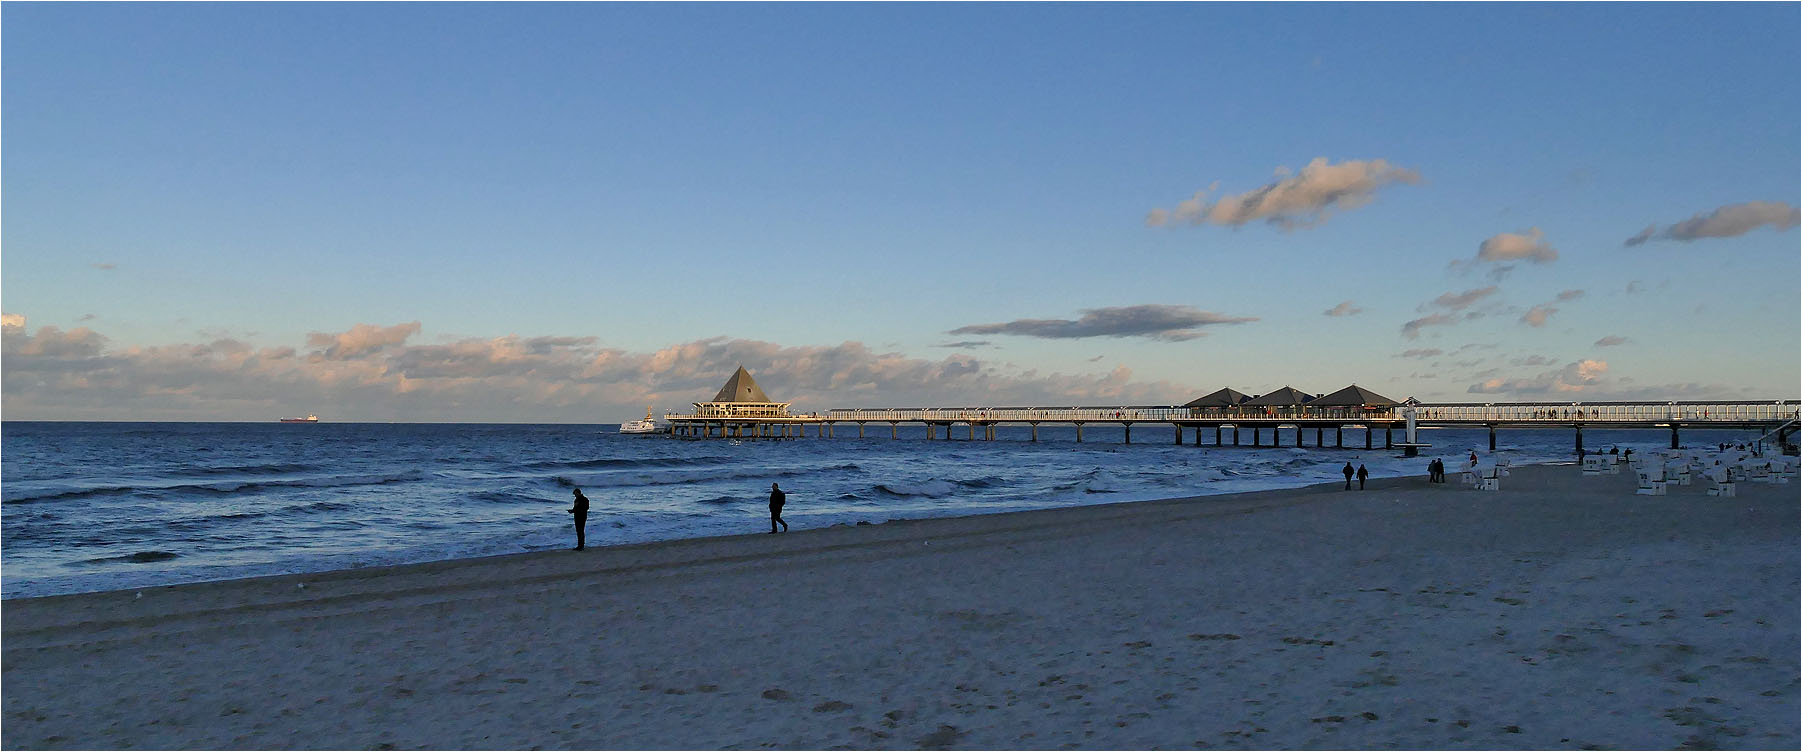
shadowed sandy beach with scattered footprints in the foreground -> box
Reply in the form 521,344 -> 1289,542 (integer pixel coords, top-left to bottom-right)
0,465 -> 1803,749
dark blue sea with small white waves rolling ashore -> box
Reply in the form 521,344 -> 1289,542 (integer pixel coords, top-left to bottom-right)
0,422 -> 1758,598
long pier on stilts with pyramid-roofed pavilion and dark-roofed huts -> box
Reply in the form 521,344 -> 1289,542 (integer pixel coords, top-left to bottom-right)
664,366 -> 1799,456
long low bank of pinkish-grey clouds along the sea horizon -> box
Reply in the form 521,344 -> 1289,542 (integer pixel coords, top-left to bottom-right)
0,315 -> 1194,423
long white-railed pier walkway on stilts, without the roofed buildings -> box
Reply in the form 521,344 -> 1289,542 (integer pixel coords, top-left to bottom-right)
664,400 -> 1798,454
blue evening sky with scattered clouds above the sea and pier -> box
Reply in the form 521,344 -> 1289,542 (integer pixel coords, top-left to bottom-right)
0,4 -> 1799,422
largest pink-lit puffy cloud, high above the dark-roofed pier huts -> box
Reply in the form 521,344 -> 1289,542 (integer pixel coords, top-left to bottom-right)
1145,157 -> 1421,231
